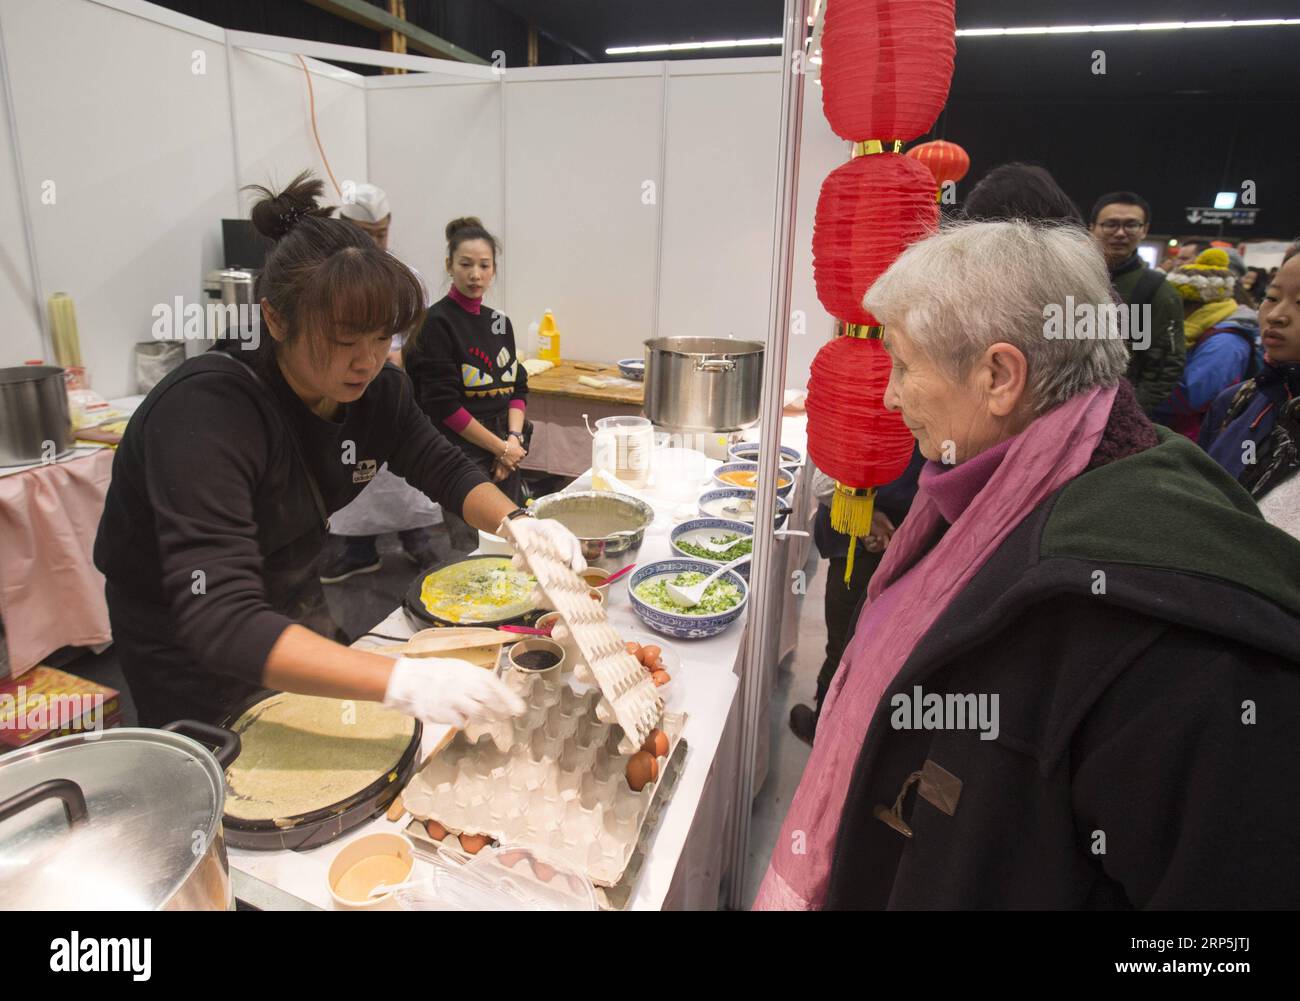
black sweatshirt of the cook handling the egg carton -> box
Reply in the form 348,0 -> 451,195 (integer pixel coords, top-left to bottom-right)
95,341 -> 486,684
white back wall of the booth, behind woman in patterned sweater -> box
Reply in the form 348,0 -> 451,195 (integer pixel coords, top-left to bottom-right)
367,57 -> 848,386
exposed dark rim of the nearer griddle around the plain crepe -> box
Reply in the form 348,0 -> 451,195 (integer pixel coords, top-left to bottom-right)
221,692 -> 424,852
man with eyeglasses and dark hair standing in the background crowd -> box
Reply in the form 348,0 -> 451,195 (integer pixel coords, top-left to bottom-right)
1089,191 -> 1187,416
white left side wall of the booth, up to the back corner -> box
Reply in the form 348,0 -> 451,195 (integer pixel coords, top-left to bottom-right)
0,0 -> 367,398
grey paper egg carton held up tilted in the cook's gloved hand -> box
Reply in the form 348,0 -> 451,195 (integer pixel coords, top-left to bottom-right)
504,523 -> 663,754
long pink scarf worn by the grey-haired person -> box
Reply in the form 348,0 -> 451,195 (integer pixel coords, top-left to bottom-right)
754,386 -> 1117,910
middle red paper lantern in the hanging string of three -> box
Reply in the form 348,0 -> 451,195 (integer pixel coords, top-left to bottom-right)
813,153 -> 939,325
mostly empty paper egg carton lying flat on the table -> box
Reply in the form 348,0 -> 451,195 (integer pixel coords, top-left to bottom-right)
402,672 -> 686,883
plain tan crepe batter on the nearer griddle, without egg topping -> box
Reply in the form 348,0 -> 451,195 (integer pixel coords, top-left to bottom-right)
226,693 -> 415,820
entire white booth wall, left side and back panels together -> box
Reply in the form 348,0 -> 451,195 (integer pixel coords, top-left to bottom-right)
0,0 -> 848,397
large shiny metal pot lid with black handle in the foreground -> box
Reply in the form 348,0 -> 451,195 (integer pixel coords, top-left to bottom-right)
0,728 -> 225,910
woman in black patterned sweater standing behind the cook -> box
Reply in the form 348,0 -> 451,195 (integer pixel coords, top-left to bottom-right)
403,217 -> 530,549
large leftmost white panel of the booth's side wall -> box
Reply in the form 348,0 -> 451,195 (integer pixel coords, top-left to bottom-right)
0,0 -> 234,395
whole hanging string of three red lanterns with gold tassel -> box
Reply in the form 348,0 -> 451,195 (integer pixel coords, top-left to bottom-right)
807,0 -> 956,582
